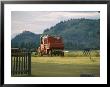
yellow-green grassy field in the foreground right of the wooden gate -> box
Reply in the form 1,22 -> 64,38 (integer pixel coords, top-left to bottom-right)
31,56 -> 100,77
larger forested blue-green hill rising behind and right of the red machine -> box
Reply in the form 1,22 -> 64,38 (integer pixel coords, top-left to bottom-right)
43,19 -> 100,50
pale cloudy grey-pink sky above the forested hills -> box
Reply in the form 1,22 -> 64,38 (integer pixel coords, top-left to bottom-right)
11,11 -> 100,38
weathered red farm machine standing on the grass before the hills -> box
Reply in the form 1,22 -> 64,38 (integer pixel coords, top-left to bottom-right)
38,35 -> 64,56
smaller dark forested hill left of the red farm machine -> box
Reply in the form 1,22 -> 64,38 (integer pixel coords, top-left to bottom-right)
11,31 -> 40,49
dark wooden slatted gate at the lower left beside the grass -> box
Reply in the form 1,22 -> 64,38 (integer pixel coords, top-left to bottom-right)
11,49 -> 31,76
